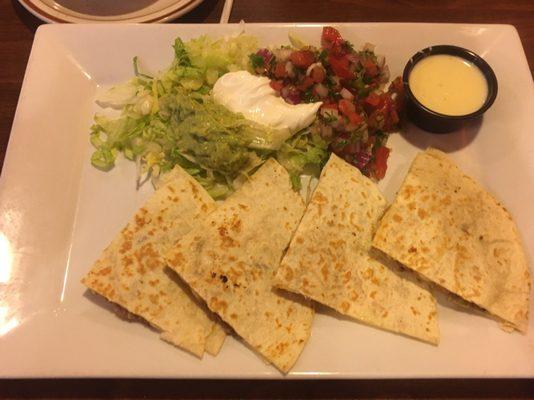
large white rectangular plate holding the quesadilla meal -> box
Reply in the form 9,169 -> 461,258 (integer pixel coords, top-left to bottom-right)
0,23 -> 534,378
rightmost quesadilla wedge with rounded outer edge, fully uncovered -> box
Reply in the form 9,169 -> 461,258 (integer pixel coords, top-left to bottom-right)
373,149 -> 530,332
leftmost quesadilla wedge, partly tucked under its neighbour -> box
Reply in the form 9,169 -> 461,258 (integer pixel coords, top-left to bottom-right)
82,167 -> 225,357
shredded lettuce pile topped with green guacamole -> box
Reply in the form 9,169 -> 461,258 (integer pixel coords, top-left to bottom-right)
91,35 -> 327,199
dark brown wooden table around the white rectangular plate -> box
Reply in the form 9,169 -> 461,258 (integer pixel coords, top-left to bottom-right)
0,0 -> 534,399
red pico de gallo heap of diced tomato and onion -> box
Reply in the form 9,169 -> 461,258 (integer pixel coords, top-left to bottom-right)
250,26 -> 404,180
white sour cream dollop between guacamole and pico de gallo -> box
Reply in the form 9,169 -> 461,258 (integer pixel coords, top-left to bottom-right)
213,71 -> 322,133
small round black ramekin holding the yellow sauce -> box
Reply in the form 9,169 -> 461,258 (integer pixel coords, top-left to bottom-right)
402,45 -> 498,133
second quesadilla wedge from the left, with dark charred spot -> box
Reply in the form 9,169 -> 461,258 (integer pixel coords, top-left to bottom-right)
167,159 -> 313,372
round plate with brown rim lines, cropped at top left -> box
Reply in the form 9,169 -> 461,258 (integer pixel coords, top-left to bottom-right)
19,0 -> 203,23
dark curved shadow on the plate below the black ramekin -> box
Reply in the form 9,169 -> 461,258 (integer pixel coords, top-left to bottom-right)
401,117 -> 483,153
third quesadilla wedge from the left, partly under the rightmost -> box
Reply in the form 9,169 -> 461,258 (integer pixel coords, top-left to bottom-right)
275,154 -> 439,344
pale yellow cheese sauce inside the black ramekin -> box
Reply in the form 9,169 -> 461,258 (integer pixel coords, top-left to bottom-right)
408,54 -> 488,115
